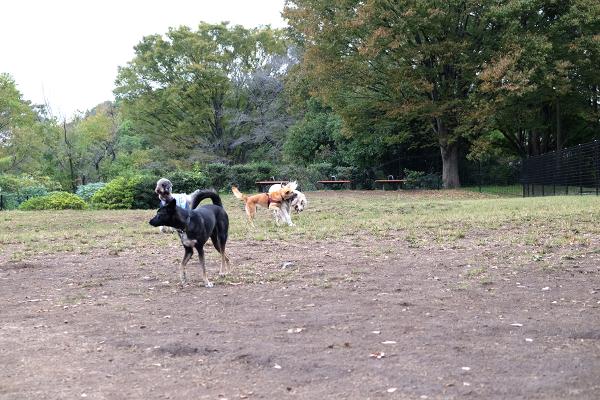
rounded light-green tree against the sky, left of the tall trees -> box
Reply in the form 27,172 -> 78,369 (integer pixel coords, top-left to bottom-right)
115,23 -> 285,166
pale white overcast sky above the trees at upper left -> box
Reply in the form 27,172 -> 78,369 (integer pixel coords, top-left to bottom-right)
0,0 -> 285,119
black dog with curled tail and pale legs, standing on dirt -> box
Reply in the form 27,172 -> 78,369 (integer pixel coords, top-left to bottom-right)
149,190 -> 229,287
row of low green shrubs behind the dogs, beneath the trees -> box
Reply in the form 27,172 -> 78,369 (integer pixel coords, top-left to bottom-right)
21,162 -> 439,209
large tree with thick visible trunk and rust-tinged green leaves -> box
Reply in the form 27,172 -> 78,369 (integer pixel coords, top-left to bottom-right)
284,0 -> 496,187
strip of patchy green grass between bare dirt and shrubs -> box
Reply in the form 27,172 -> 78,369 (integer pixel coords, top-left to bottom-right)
0,190 -> 600,261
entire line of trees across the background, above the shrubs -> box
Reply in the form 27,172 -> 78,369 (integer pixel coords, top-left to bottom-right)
0,0 -> 600,192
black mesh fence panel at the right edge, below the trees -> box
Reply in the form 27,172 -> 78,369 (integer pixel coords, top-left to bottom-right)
521,141 -> 600,196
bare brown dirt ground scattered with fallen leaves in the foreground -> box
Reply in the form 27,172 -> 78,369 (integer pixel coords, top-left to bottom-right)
0,196 -> 600,399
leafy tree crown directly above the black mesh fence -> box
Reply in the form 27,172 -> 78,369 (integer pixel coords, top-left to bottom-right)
477,0 -> 600,157
